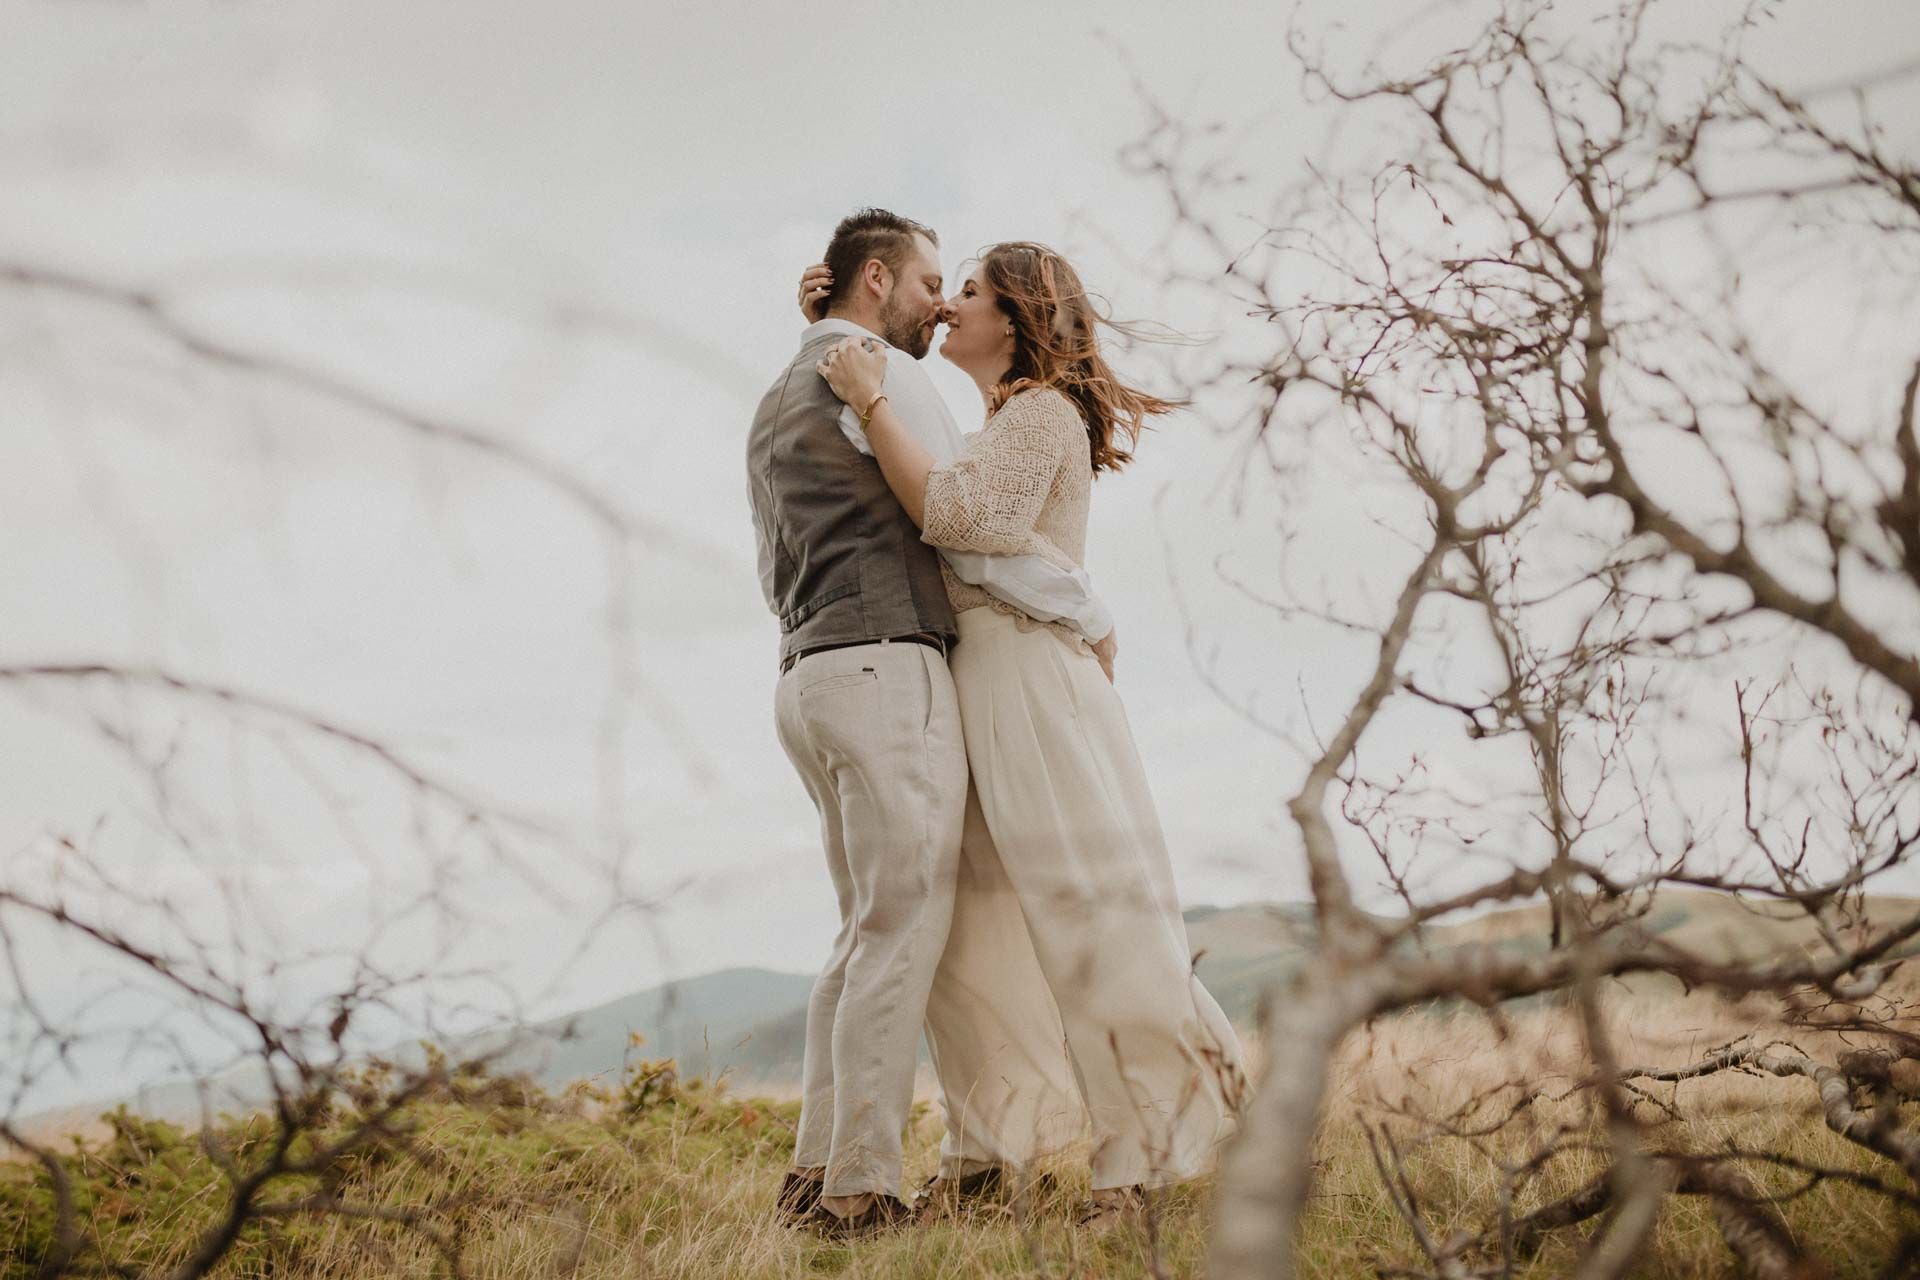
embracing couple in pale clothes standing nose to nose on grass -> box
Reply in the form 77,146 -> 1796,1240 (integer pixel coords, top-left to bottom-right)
747,209 -> 1244,1236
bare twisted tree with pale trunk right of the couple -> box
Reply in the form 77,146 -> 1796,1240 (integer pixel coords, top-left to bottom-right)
1129,2 -> 1920,1278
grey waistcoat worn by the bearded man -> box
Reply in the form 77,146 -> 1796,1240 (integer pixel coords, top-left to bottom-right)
747,332 -> 956,660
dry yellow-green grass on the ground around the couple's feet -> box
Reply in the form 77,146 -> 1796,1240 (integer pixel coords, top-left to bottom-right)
0,974 -> 1916,1280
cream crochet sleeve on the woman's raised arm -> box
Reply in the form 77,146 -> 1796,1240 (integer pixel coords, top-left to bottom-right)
920,388 -> 1087,555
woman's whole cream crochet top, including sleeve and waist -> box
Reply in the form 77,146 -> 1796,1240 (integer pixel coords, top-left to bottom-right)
920,388 -> 1092,647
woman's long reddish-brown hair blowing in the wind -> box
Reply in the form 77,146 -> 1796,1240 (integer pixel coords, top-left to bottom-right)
979,240 -> 1185,472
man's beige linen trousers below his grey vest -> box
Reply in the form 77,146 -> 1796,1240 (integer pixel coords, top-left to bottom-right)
774,641 -> 968,1196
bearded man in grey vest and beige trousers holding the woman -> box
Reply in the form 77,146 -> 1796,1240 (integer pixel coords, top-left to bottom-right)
747,209 -> 1112,1234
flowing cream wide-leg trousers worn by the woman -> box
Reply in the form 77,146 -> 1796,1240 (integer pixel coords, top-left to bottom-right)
927,608 -> 1244,1190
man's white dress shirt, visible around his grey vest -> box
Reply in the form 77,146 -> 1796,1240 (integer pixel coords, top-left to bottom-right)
801,317 -> 1114,643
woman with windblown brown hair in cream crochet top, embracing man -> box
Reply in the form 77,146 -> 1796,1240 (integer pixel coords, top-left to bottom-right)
801,242 -> 1244,1224
